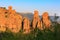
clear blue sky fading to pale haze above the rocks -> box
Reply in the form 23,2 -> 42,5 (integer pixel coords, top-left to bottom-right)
0,0 -> 60,16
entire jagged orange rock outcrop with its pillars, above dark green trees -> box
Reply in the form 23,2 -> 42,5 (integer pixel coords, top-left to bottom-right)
0,6 -> 51,34
